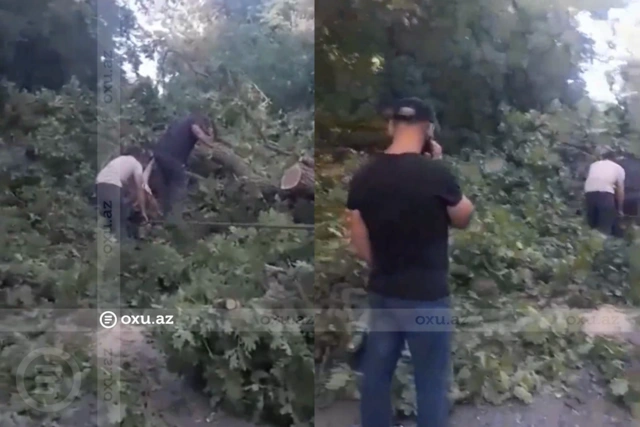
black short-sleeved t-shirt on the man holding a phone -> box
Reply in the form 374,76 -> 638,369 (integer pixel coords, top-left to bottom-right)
347,153 -> 462,301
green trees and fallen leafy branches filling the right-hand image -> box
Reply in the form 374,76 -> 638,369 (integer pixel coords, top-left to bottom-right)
314,1 -> 638,415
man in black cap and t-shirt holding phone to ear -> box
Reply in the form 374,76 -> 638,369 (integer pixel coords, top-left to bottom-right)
347,98 -> 474,427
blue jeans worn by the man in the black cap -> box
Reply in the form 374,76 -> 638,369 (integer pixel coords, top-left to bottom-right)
360,294 -> 453,427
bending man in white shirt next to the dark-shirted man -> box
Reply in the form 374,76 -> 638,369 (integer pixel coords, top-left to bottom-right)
96,147 -> 151,241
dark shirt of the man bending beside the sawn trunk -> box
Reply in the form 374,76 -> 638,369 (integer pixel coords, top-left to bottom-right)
155,114 -> 207,164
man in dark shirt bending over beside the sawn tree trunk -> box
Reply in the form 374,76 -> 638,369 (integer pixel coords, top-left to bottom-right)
145,113 -> 216,222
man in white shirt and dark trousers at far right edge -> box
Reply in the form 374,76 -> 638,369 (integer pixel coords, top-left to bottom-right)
584,152 -> 625,235
